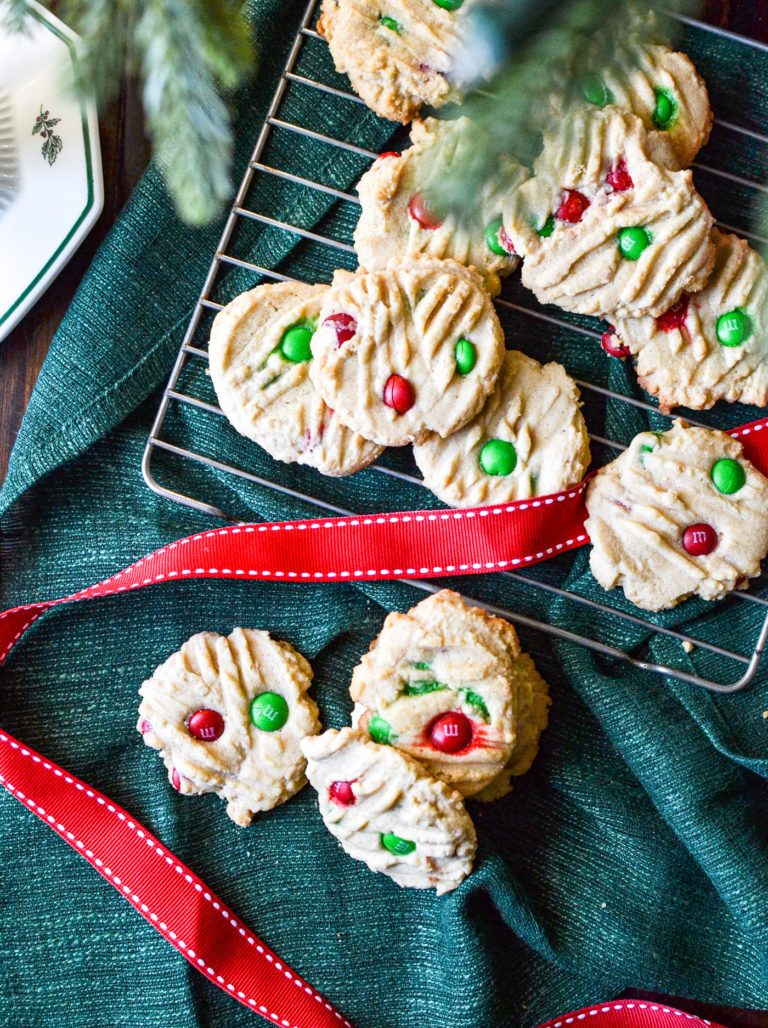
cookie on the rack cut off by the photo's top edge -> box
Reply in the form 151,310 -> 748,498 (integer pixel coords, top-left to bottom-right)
318,0 -> 473,124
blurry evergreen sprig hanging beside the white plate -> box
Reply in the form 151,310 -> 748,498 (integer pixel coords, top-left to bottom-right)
5,0 -> 254,225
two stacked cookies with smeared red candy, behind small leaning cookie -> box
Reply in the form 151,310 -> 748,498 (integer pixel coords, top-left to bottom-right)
350,589 -> 549,800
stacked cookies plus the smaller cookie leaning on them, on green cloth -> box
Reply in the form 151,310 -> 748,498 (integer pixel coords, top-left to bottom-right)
302,589 -> 549,895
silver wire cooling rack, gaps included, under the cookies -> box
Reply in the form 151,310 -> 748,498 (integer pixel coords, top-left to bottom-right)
142,0 -> 768,693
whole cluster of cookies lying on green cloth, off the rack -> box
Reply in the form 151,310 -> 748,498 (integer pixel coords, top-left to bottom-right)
137,590 -> 549,894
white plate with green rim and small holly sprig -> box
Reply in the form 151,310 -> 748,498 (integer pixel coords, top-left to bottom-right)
0,0 -> 104,340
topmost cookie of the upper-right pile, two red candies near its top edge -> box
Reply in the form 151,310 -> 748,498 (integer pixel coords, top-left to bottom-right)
504,111 -> 715,317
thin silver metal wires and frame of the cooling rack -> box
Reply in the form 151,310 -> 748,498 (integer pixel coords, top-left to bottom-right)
142,0 -> 768,693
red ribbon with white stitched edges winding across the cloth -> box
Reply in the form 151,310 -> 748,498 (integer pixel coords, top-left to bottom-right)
0,418 -> 768,1028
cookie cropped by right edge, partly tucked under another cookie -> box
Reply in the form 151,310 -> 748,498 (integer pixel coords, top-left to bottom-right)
612,229 -> 768,412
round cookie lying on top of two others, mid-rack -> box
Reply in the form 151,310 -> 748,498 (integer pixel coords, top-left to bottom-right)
309,257 -> 504,446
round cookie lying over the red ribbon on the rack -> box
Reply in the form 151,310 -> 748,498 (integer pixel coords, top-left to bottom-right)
585,421 -> 768,611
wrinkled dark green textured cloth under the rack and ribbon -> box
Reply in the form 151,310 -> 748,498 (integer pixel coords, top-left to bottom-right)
0,0 -> 768,1028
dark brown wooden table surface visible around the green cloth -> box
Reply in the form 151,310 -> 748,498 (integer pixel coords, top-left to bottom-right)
0,0 -> 768,1028
